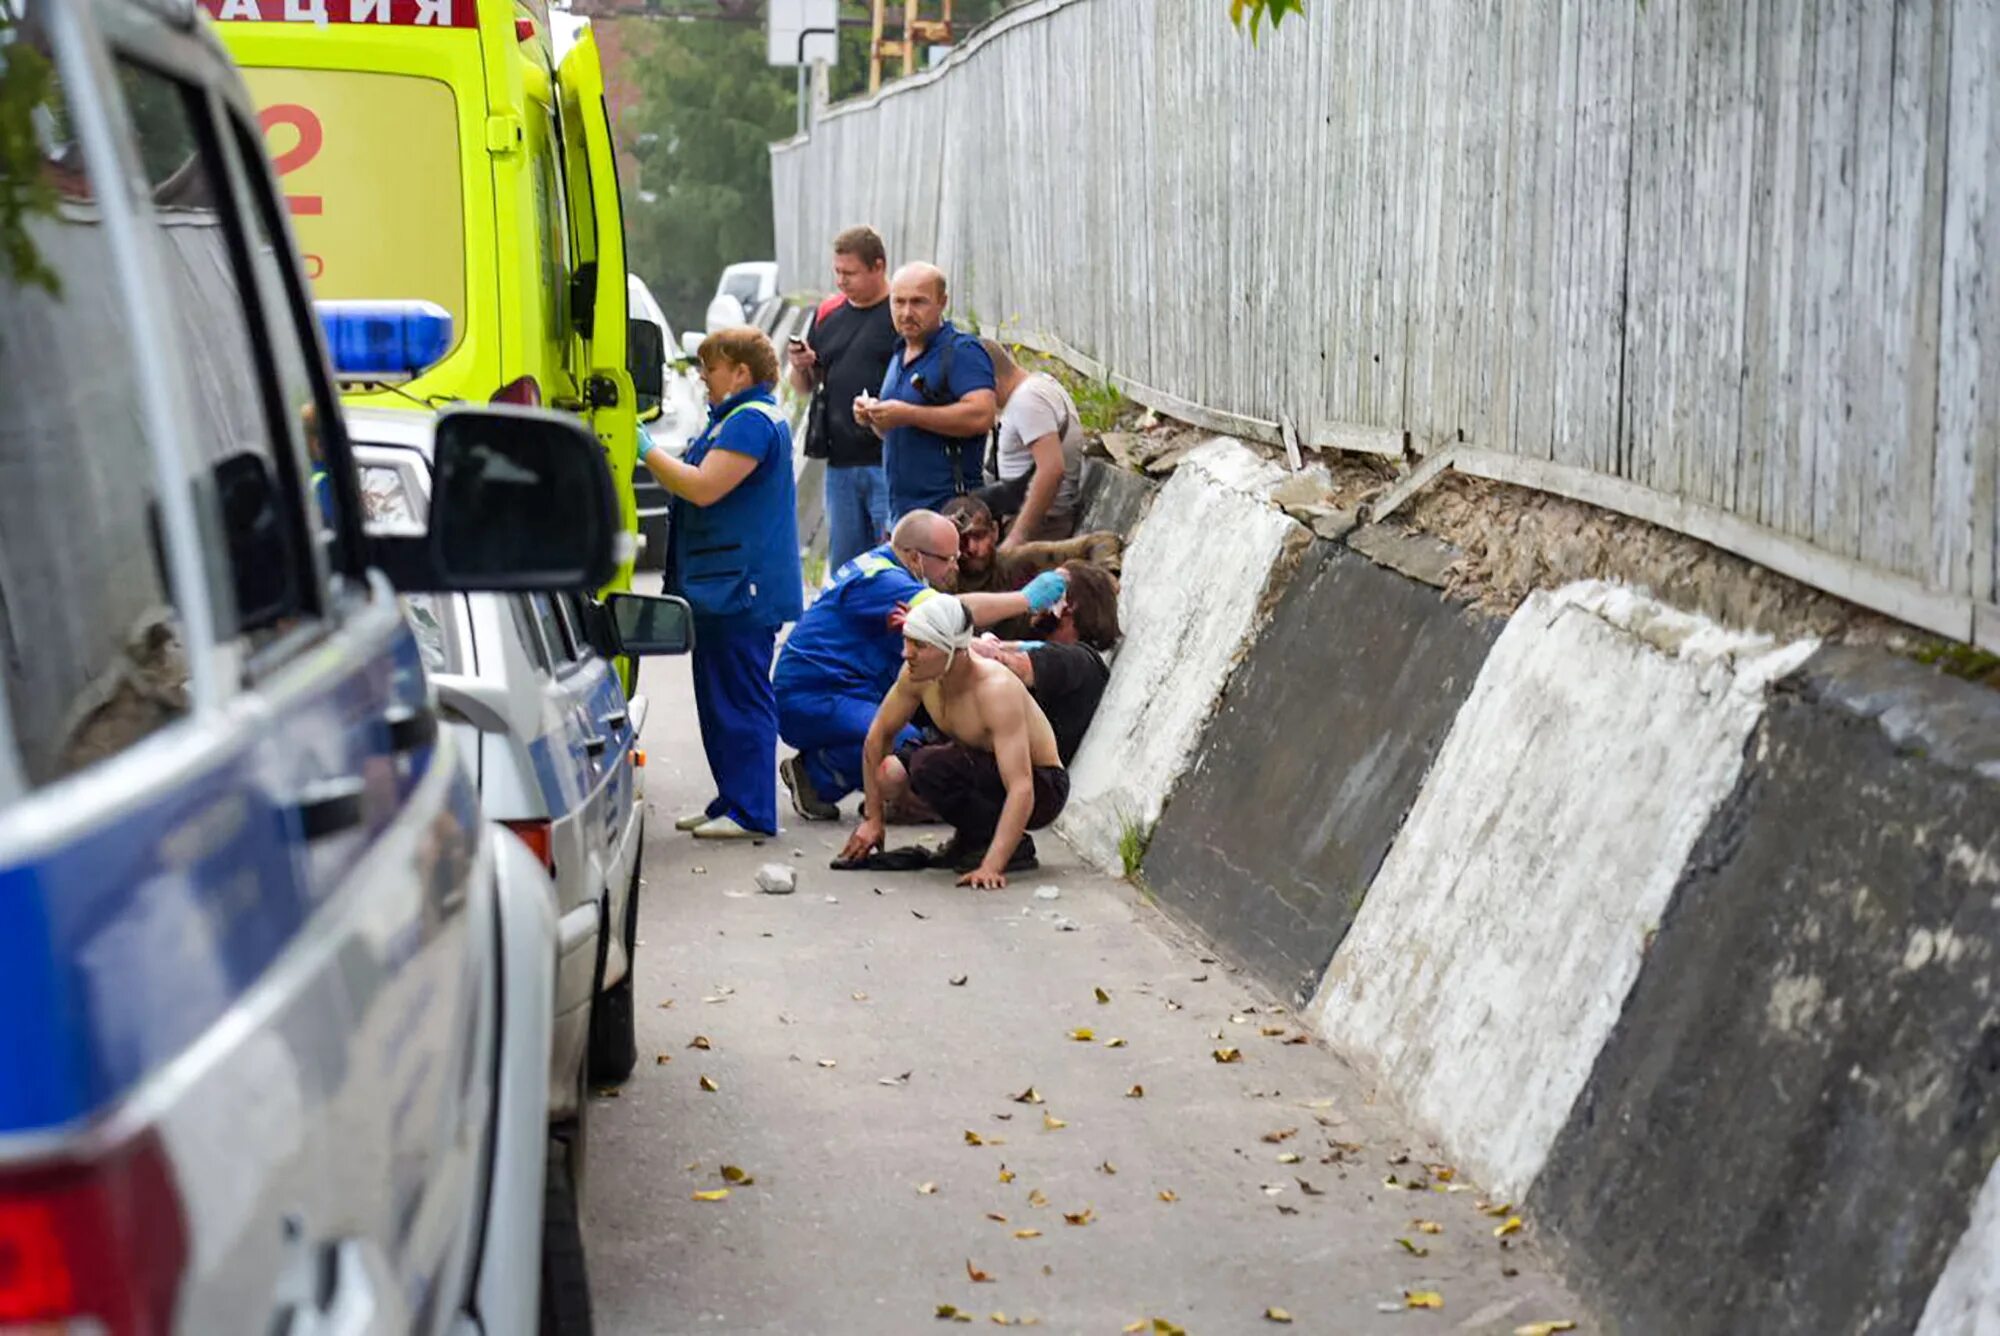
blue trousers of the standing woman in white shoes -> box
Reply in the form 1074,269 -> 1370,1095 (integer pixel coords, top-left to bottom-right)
694,618 -> 778,834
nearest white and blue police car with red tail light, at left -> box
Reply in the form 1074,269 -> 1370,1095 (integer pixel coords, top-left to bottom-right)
0,0 -> 618,1336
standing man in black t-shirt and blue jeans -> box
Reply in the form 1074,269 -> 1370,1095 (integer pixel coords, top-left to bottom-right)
790,228 -> 898,570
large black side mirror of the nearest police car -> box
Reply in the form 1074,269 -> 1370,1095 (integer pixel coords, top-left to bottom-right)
368,404 -> 620,592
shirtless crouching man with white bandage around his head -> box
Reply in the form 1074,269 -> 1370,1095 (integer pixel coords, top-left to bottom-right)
840,594 -> 1070,890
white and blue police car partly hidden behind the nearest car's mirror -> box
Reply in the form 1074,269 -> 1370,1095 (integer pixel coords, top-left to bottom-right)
348,408 -> 692,1118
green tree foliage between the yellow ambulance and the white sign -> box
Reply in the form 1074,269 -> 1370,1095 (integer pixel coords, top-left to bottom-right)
618,22 -> 798,330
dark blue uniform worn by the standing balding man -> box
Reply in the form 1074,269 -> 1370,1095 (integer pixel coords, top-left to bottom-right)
880,320 -> 994,524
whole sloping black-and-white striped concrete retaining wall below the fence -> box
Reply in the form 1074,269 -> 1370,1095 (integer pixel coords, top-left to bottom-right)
1066,446 -> 2000,1336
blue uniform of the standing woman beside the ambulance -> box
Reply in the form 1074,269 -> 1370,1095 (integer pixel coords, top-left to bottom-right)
666,384 -> 804,834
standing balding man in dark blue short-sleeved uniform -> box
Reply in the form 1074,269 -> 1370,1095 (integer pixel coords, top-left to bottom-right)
854,264 -> 1000,522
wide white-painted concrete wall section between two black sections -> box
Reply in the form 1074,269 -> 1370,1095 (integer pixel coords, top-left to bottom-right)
1314,584 -> 1810,1194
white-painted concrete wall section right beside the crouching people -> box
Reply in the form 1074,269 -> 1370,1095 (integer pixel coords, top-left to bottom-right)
1058,438 -> 1306,870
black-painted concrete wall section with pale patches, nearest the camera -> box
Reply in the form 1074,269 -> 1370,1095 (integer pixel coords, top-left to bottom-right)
1530,650 -> 2000,1334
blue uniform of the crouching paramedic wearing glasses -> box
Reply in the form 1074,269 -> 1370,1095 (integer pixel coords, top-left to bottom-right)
776,544 -> 930,802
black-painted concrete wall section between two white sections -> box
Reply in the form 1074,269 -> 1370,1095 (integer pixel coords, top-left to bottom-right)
1146,544 -> 1506,1004
